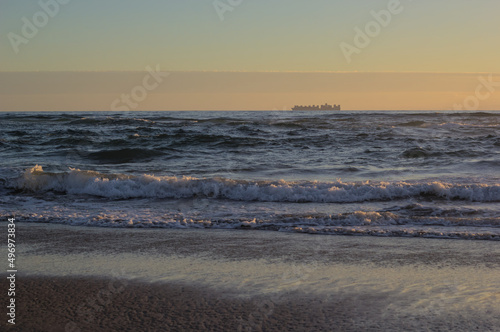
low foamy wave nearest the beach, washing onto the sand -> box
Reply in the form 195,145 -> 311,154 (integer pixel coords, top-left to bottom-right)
0,207 -> 500,241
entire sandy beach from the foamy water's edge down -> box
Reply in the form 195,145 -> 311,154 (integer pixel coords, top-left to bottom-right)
2,223 -> 500,331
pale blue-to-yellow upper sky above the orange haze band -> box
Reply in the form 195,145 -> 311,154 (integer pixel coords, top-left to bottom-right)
0,0 -> 500,72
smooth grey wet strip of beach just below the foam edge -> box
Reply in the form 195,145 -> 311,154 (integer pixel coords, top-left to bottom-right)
11,221 -> 500,269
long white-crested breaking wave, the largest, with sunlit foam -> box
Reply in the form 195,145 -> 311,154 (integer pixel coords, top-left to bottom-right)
8,165 -> 500,203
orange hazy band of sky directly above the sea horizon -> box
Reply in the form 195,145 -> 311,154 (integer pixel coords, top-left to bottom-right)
0,72 -> 500,111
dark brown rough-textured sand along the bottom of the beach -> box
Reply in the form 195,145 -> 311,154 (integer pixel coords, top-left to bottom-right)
7,277 -> 498,331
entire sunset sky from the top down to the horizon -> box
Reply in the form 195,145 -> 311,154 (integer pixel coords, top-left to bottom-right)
0,0 -> 500,111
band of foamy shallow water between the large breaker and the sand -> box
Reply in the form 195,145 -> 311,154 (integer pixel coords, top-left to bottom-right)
0,180 -> 500,241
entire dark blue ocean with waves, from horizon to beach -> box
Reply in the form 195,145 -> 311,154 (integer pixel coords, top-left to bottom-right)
0,111 -> 500,241
